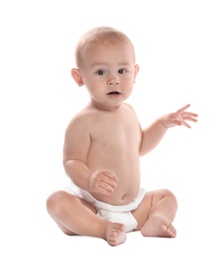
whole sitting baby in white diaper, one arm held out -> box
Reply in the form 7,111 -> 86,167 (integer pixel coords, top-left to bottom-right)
47,27 -> 197,246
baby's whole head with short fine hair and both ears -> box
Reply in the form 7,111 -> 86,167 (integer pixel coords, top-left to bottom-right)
71,27 -> 139,109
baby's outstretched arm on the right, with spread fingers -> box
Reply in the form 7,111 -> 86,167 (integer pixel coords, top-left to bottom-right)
140,104 -> 198,156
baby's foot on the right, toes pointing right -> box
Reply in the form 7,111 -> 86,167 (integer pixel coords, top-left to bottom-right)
141,216 -> 176,238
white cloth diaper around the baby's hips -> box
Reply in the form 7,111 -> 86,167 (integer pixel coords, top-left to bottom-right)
64,182 -> 146,232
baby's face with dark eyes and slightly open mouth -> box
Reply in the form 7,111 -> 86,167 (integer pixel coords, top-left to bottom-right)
80,42 -> 138,109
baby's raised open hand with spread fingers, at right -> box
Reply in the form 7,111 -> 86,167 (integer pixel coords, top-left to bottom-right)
161,104 -> 198,128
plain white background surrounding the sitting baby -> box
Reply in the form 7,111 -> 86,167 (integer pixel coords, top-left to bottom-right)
0,0 -> 221,259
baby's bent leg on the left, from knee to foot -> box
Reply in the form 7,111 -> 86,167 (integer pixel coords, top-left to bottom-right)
47,191 -> 126,245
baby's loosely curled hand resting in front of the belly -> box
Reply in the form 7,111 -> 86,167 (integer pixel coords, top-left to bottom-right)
90,170 -> 118,195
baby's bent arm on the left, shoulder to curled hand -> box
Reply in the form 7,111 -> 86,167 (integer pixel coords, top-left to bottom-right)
63,118 -> 117,195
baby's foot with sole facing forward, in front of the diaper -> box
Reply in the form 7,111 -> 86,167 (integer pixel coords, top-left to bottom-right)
106,222 -> 127,246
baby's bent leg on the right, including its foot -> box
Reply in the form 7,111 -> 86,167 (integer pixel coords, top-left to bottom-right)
133,190 -> 177,237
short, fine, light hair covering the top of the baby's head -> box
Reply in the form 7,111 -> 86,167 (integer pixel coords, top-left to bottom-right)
75,26 -> 135,69
